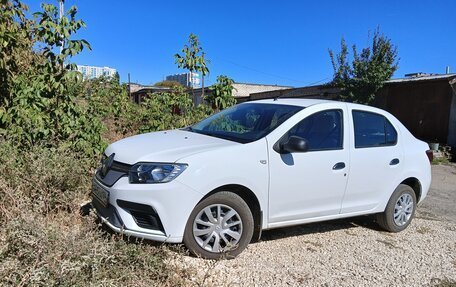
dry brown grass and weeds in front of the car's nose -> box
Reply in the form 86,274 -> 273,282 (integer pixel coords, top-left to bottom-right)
0,142 -> 200,286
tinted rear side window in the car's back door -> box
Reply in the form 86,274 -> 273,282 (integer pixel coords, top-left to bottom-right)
353,111 -> 397,148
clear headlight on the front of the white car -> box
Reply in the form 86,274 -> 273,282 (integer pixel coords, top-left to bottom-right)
130,163 -> 187,183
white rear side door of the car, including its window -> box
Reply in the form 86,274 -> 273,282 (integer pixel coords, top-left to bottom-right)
341,109 -> 403,213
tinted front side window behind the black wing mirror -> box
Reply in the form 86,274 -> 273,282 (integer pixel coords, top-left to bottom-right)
286,110 -> 343,151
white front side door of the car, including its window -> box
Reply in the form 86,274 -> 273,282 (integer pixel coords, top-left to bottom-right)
268,109 -> 349,225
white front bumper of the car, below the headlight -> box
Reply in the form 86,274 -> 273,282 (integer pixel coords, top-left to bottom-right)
92,177 -> 203,243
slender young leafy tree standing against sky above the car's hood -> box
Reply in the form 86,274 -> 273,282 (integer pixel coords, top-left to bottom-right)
174,34 -> 209,97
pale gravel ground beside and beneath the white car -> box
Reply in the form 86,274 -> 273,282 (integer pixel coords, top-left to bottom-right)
170,166 -> 456,286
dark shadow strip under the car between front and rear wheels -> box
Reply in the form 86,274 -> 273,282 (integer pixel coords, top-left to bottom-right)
258,215 -> 382,242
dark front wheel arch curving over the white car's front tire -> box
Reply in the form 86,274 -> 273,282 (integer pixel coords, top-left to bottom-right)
199,184 -> 263,242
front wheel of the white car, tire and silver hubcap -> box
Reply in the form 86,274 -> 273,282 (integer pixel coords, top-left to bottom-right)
184,191 -> 254,259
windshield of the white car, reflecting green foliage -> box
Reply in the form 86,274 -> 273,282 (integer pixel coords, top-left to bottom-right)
188,103 -> 303,143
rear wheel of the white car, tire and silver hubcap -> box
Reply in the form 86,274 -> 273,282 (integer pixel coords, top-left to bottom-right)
377,184 -> 416,232
